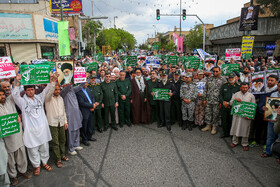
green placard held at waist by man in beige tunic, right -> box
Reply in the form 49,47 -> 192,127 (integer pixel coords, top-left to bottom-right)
231,100 -> 257,119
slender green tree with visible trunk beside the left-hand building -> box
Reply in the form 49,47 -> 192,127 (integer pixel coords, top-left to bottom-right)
83,20 -> 103,53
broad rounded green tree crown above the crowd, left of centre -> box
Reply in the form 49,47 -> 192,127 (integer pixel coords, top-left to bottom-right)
96,28 -> 136,50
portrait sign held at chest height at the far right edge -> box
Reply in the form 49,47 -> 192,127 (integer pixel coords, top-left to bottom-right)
264,97 -> 280,121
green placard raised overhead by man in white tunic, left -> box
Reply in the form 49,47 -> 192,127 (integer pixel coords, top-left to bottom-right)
19,64 -> 50,85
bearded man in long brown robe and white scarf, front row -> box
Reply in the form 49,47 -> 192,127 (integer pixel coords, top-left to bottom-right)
130,68 -> 150,125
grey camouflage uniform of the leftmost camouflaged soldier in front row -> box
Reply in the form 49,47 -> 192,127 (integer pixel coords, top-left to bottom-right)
180,82 -> 198,122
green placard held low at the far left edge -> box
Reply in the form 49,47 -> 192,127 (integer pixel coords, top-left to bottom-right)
0,113 -> 20,138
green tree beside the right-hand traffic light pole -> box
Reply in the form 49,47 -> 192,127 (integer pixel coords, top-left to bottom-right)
184,25 -> 203,50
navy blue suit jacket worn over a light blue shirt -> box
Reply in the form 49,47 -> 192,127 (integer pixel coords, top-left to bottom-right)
76,88 -> 95,120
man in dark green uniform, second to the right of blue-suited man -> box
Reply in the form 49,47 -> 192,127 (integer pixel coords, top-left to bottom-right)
101,73 -> 119,131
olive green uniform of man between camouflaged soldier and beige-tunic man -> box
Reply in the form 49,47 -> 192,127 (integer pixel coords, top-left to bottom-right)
219,83 -> 240,136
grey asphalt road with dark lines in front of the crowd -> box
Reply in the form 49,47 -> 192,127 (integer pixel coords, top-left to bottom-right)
17,124 -> 280,187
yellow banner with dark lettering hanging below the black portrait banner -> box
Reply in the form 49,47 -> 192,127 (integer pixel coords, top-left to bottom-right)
241,36 -> 255,60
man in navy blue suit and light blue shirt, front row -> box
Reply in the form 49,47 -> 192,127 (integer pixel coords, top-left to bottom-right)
76,84 -> 96,146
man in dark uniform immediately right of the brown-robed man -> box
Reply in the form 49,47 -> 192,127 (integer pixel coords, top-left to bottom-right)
147,70 -> 159,124
